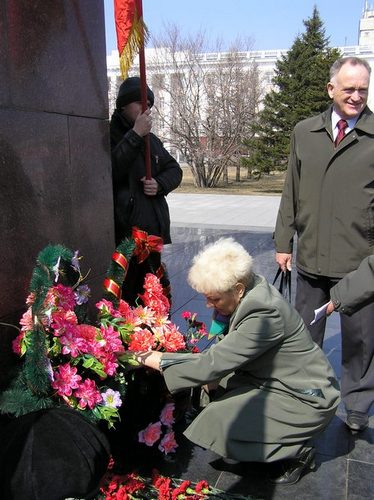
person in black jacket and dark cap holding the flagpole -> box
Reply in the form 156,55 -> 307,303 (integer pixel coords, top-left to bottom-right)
110,77 -> 182,305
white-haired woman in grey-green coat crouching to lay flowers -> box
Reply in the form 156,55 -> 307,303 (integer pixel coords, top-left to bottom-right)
137,238 -> 340,484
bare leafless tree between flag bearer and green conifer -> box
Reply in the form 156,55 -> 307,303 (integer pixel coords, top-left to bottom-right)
147,26 -> 260,187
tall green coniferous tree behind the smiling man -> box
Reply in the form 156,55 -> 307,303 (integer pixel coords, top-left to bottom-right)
244,7 -> 340,173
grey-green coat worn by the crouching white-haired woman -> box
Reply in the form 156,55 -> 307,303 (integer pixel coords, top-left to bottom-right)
161,275 -> 340,462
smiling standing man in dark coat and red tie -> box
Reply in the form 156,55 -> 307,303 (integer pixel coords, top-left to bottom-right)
274,57 -> 374,432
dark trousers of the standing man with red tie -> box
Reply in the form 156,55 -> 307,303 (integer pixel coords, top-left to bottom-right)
295,273 -> 374,413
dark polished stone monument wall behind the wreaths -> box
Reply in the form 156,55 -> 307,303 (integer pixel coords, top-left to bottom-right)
0,0 -> 114,386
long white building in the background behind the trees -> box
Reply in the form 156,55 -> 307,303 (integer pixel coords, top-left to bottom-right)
107,1 -> 374,125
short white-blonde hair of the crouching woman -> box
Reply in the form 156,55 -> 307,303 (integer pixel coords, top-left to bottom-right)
188,238 -> 252,294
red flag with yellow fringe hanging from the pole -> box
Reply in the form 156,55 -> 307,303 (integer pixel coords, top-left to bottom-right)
114,0 -> 148,79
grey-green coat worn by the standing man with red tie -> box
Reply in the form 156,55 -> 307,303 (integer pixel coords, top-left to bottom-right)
274,107 -> 374,278
